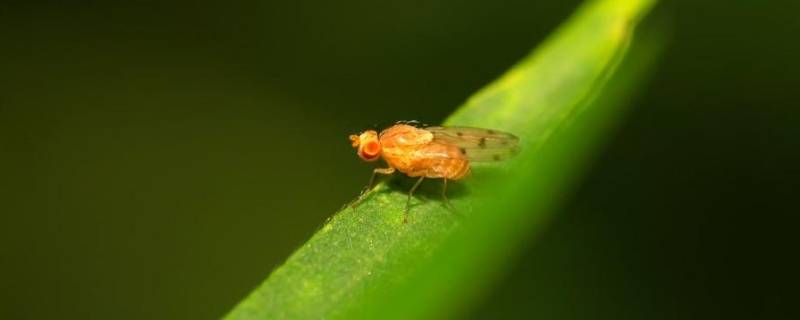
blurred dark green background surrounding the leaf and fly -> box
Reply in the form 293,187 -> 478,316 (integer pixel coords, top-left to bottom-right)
0,0 -> 800,319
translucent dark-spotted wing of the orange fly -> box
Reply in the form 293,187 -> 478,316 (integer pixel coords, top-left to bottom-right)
425,127 -> 519,162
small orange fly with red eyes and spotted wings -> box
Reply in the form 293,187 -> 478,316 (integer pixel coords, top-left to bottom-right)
350,123 -> 519,223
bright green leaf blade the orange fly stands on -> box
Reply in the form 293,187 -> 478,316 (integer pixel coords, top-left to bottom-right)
227,0 -> 658,319
